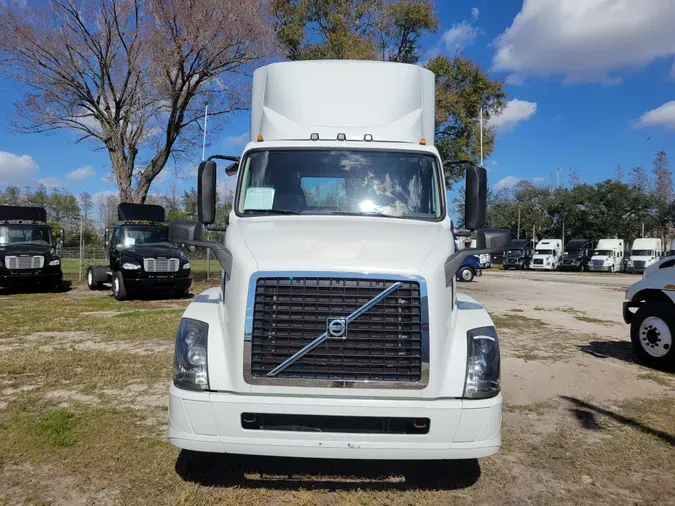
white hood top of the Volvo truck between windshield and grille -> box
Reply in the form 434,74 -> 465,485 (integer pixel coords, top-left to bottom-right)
233,216 -> 449,274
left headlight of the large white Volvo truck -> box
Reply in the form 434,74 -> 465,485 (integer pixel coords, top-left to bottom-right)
173,318 -> 209,390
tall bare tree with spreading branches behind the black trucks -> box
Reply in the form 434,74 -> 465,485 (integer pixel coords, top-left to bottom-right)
0,0 -> 274,202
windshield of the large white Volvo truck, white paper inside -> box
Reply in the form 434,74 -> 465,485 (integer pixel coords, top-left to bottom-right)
236,150 -> 444,220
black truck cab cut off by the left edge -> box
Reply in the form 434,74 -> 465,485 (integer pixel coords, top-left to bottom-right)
0,206 -> 63,291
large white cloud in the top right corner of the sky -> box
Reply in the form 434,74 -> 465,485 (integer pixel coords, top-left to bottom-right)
493,0 -> 675,84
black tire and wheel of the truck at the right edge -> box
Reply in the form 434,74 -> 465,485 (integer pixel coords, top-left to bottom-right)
630,302 -> 675,369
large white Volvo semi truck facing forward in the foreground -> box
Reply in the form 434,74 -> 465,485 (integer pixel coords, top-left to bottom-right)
168,61 -> 511,459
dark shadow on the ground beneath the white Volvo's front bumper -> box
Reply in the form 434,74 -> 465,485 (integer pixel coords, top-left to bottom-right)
176,450 -> 480,491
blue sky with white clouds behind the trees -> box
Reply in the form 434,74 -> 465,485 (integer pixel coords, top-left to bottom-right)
0,0 -> 675,211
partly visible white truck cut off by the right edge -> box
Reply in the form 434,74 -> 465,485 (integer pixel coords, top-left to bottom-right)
623,258 -> 675,368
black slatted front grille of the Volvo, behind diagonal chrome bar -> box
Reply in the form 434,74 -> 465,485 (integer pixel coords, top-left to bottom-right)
251,278 -> 428,382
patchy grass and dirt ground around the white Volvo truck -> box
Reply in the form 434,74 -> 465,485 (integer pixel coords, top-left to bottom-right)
0,269 -> 675,506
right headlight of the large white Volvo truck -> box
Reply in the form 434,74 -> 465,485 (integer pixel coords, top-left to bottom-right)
464,327 -> 500,399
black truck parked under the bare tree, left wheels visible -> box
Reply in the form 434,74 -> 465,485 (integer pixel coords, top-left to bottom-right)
87,204 -> 192,300
